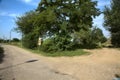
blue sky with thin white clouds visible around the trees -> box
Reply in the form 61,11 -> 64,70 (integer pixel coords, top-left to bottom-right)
0,0 -> 110,39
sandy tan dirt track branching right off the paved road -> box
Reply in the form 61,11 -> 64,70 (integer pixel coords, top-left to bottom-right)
44,48 -> 120,80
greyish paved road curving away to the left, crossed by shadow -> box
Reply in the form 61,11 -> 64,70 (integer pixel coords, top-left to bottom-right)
0,45 -> 75,80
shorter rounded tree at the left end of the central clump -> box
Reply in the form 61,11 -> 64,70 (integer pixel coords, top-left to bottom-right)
16,11 -> 39,48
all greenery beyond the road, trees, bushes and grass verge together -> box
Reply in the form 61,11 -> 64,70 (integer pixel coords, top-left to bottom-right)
2,0 -> 120,56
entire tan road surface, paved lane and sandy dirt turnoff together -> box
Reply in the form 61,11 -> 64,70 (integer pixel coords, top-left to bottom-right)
0,45 -> 120,80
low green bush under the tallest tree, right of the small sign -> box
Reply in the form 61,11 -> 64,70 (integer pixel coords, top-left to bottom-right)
41,37 -> 74,52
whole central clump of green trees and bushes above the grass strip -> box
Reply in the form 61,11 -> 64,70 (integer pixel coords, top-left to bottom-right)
16,0 -> 106,52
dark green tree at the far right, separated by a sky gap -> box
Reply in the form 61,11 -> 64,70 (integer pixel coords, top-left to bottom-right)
104,0 -> 120,47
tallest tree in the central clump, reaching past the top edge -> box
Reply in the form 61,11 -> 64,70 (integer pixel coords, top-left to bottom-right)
36,0 -> 99,50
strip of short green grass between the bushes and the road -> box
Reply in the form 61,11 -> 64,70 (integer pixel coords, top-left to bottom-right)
12,43 -> 90,57
